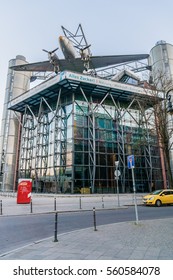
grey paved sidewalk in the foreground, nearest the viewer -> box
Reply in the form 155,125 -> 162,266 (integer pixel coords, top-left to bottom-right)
0,218 -> 173,260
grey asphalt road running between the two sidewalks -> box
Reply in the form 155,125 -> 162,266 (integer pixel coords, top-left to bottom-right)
0,206 -> 173,254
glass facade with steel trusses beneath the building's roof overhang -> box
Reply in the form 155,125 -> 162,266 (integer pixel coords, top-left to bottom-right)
19,86 -> 162,193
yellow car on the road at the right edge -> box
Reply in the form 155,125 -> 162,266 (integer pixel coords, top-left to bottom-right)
142,189 -> 173,207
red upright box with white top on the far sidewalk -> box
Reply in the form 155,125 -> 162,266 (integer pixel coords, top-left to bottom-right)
17,179 -> 32,204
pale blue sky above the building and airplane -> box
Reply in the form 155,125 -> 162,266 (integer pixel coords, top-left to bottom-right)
0,0 -> 173,128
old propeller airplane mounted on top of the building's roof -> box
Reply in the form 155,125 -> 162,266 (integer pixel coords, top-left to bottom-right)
10,24 -> 149,73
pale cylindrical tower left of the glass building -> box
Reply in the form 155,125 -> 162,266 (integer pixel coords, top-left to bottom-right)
0,55 -> 31,191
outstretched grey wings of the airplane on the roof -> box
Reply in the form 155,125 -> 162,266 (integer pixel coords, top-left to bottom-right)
10,54 -> 149,72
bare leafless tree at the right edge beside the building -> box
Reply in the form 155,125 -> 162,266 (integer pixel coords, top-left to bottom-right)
137,73 -> 173,187
